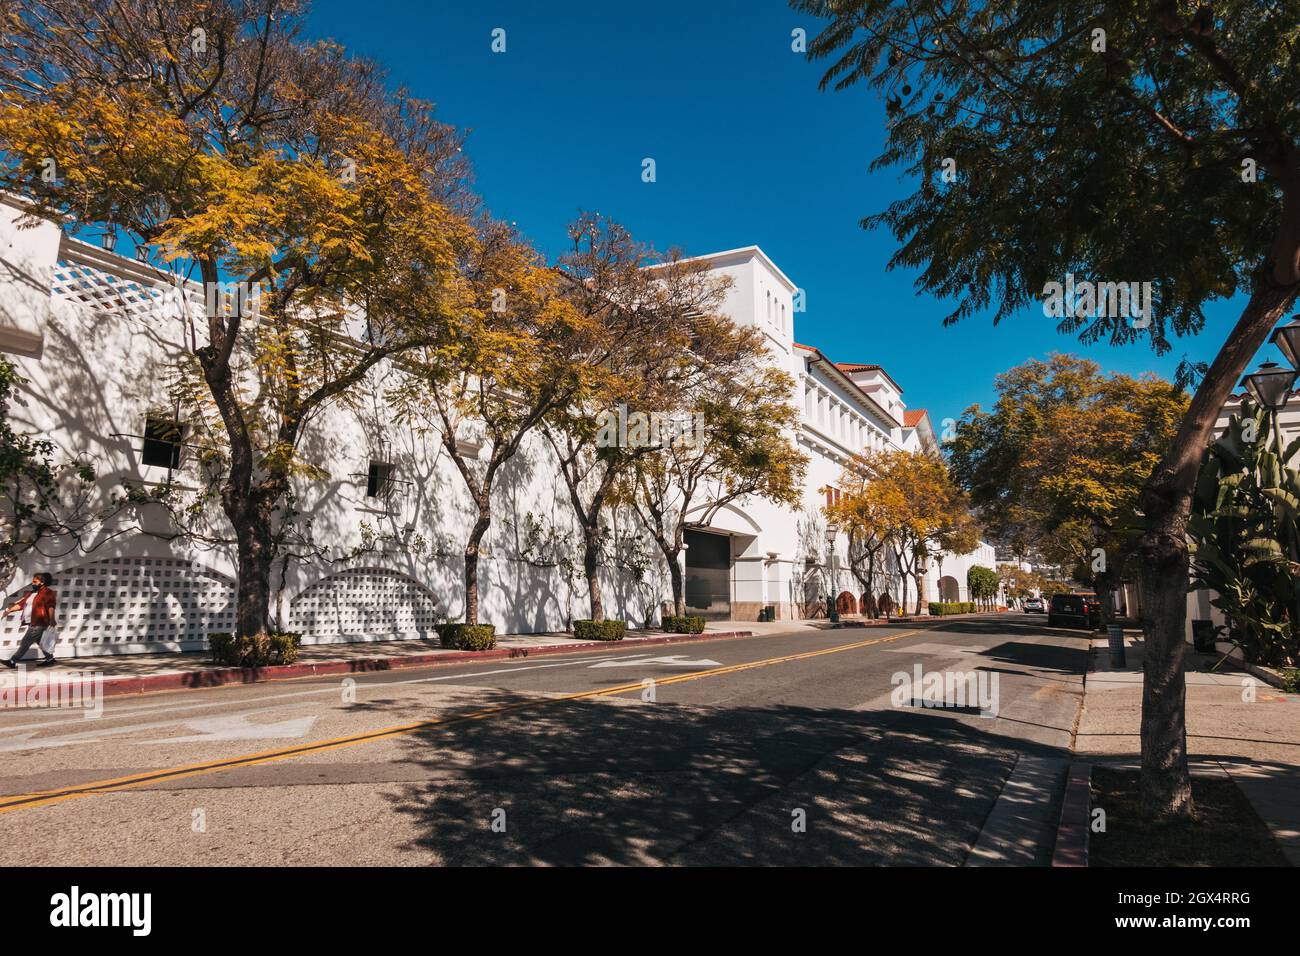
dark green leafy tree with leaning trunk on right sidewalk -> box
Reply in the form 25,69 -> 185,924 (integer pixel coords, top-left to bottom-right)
792,0 -> 1300,816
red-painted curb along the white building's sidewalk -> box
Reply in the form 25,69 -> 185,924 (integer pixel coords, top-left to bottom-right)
10,631 -> 754,697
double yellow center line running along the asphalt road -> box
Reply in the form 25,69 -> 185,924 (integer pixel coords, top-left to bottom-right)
0,628 -> 928,813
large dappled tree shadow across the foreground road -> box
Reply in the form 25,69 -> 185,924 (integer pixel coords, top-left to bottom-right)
379,692 -> 1069,865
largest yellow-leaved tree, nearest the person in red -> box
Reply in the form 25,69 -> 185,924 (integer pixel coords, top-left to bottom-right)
0,0 -> 477,636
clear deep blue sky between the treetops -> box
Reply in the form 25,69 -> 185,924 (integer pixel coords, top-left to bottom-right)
308,0 -> 1271,425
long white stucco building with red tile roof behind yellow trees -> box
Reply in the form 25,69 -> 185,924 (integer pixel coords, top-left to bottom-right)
0,197 -> 996,656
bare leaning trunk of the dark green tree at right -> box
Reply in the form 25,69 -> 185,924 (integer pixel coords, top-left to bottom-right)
1139,277 -> 1296,817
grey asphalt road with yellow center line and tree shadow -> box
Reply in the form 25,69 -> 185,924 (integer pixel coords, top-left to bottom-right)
0,614 -> 1088,865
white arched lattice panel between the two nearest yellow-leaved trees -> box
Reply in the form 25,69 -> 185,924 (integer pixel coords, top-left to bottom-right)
289,567 -> 437,639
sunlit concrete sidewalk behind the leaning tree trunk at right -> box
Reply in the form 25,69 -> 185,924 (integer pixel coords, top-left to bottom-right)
1075,632 -> 1300,866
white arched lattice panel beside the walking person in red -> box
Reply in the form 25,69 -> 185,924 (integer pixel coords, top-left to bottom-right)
0,558 -> 235,654
